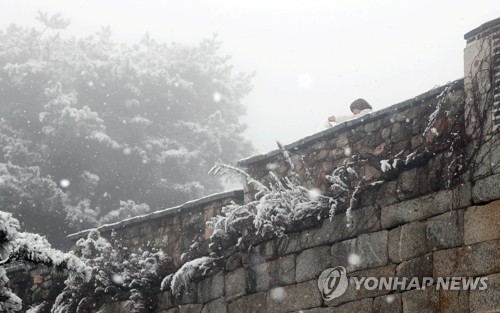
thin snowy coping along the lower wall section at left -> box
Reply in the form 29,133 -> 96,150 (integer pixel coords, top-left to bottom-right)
66,189 -> 243,240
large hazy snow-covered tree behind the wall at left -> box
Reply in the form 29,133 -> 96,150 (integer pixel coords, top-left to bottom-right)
0,13 -> 251,240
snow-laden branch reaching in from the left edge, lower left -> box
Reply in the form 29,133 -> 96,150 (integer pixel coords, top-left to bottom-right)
0,211 -> 91,312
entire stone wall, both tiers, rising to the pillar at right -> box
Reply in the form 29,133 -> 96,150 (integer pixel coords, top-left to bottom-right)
8,16 -> 500,313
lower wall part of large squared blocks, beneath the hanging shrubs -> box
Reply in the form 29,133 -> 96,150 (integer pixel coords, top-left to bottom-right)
150,190 -> 500,313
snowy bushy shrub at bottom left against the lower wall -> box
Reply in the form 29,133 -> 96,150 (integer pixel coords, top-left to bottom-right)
52,230 -> 168,312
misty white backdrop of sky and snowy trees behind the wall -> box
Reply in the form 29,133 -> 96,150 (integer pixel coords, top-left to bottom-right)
0,0 -> 500,243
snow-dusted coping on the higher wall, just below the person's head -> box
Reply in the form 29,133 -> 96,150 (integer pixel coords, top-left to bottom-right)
237,80 -> 464,167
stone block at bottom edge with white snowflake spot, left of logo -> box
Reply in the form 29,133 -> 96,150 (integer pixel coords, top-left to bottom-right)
267,280 -> 323,312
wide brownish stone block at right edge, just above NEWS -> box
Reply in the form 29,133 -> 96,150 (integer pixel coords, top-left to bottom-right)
433,240 -> 500,277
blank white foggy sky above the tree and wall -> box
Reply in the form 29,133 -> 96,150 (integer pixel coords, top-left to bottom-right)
0,0 -> 500,152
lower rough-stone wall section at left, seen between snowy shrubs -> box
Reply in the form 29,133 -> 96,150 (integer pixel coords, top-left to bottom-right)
7,190 -> 243,312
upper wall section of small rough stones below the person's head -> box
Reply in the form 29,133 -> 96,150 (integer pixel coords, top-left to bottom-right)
239,80 -> 465,206
